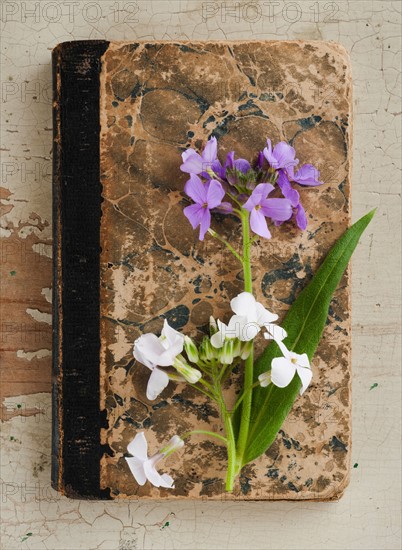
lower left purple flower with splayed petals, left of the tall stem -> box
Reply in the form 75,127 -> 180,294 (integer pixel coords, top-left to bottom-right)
183,174 -> 225,241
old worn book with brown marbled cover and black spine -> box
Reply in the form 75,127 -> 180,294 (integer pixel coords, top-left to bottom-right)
52,41 -> 351,500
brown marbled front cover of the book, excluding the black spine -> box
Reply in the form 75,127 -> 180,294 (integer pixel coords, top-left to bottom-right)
101,42 -> 351,499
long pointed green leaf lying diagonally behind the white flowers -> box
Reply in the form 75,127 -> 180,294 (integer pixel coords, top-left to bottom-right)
243,210 -> 375,465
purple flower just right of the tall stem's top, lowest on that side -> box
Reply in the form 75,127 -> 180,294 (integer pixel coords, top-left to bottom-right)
243,183 -> 292,239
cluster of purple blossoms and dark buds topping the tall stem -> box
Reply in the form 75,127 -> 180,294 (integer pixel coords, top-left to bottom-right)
180,137 -> 322,240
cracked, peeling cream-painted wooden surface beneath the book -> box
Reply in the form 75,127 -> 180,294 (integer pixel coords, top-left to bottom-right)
1,0 -> 401,550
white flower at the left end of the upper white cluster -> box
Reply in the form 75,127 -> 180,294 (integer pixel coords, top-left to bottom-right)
134,319 -> 184,401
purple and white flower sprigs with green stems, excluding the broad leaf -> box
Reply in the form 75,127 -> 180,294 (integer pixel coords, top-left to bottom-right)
126,138 -> 322,490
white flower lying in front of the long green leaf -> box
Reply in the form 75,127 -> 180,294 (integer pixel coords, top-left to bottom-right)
268,341 -> 313,395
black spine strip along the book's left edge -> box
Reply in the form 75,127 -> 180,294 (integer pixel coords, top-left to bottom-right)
52,41 -> 110,499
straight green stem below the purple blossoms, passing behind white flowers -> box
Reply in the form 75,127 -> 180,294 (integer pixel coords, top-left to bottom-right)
236,209 -> 254,473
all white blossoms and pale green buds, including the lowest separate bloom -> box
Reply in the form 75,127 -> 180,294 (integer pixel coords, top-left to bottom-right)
133,292 -> 312,488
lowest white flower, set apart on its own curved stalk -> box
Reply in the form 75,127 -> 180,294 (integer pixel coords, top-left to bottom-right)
126,432 -> 184,489
